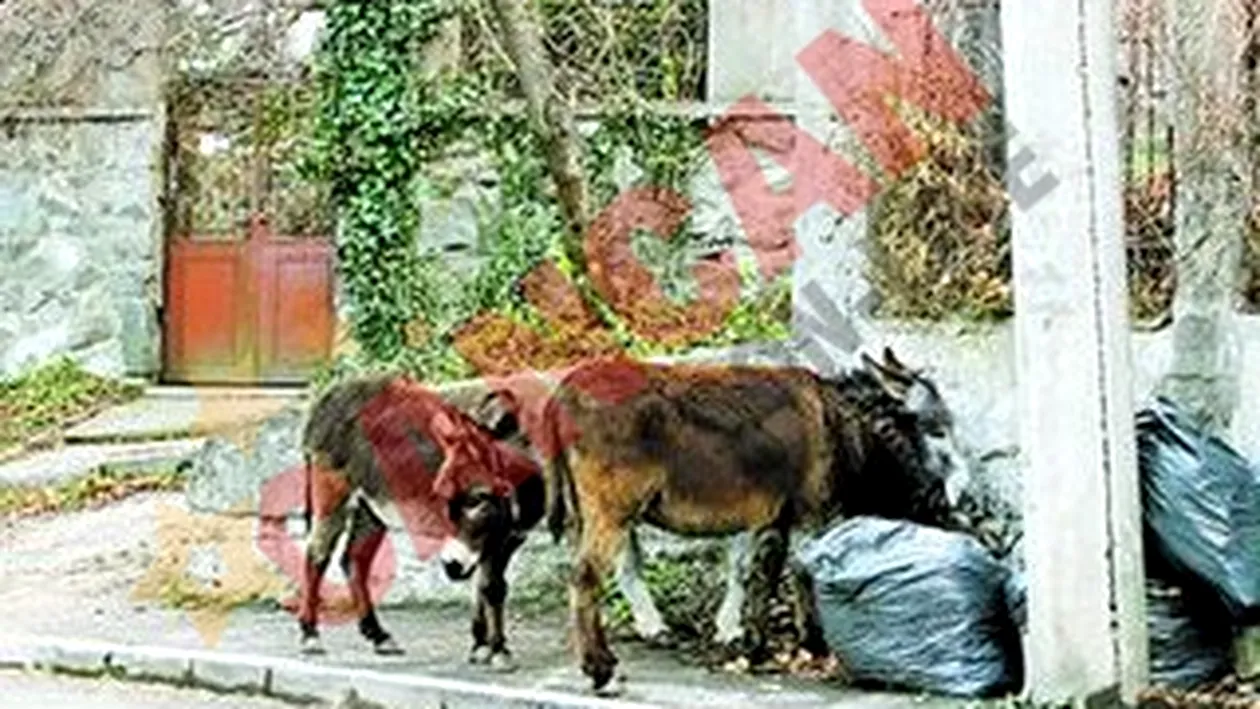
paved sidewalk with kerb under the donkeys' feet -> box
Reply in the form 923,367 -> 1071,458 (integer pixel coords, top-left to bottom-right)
0,494 -> 963,709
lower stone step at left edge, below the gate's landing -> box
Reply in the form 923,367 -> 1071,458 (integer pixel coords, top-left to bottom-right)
0,438 -> 205,486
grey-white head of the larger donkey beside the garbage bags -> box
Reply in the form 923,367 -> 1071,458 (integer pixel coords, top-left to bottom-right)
862,348 -> 971,508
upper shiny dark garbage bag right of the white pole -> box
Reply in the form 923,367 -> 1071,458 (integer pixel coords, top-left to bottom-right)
1137,398 -> 1260,622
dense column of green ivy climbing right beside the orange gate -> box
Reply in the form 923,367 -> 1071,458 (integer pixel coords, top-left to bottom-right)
309,0 -> 470,361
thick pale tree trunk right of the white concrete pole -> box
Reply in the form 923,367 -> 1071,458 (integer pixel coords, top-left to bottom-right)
1158,0 -> 1251,434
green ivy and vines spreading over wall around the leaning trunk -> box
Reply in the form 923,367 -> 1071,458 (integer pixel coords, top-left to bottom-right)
299,0 -> 790,388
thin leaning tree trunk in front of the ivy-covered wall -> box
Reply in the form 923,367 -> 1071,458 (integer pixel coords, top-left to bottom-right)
490,0 -> 592,272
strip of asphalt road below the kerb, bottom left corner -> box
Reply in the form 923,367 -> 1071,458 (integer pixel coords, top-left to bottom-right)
0,670 -> 315,709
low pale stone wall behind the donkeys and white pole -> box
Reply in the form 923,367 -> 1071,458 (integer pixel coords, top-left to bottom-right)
180,316 -> 1260,603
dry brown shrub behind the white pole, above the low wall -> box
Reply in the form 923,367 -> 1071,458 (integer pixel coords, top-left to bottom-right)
868,106 -> 1179,324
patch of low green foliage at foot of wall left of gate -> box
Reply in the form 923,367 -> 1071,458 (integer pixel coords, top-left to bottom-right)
0,358 -> 141,450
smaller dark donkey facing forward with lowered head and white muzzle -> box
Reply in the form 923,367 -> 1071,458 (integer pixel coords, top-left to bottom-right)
299,377 -> 544,669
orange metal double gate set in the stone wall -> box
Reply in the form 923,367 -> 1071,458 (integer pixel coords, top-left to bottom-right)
163,77 -> 334,384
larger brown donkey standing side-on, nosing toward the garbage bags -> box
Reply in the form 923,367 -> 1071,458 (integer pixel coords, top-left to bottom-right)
544,350 -> 968,690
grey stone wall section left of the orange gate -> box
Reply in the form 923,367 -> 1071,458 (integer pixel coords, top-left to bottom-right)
0,0 -> 164,375
